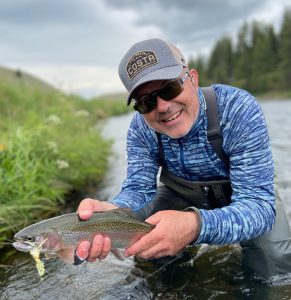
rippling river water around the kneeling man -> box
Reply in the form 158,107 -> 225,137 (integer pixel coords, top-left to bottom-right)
0,100 -> 291,300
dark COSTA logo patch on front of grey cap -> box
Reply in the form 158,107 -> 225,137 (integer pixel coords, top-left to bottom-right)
126,51 -> 158,79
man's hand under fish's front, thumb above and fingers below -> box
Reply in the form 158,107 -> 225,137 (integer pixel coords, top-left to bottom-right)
76,198 -> 118,262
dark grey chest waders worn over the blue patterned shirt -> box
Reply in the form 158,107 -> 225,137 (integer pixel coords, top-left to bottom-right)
151,88 -> 291,279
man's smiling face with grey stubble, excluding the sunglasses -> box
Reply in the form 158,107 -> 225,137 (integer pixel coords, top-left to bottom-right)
137,69 -> 199,138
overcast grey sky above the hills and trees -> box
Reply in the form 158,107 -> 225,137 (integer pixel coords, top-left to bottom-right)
0,0 -> 290,96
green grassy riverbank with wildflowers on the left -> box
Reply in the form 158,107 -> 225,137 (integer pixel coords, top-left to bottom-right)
0,82 -> 128,248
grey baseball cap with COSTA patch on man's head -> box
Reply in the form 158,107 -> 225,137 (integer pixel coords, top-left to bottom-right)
118,39 -> 187,105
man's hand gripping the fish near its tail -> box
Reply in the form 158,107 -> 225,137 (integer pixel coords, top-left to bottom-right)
125,210 -> 198,259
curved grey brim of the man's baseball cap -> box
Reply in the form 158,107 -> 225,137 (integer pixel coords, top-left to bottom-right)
127,65 -> 183,105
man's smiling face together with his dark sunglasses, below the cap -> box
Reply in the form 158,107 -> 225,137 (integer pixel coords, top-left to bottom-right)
133,69 -> 199,139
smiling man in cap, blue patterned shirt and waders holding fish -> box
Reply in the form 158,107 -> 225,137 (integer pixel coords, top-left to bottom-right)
76,39 -> 291,277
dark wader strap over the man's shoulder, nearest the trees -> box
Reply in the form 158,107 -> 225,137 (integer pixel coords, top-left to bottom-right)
201,86 -> 229,167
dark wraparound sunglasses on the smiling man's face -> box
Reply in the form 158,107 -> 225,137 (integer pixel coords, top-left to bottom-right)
133,72 -> 189,114
